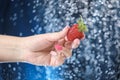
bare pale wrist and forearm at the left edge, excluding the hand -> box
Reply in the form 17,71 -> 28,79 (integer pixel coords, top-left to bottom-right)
0,35 -> 22,62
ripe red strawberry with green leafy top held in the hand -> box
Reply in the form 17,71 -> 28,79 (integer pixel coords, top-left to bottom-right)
67,17 -> 88,41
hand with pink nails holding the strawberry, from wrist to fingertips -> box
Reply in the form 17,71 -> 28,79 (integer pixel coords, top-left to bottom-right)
21,27 -> 80,66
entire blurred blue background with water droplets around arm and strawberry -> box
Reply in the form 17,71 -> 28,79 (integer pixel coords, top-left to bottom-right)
0,0 -> 120,80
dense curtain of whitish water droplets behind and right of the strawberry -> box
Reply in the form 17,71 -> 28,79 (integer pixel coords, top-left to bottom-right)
40,0 -> 120,80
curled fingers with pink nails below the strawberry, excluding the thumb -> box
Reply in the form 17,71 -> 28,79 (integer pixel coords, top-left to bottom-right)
50,39 -> 80,66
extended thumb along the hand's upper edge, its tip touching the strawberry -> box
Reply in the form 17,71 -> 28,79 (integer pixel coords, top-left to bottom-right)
48,26 -> 69,41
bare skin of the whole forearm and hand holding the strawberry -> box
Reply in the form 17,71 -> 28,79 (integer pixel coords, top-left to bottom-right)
0,27 -> 80,66
